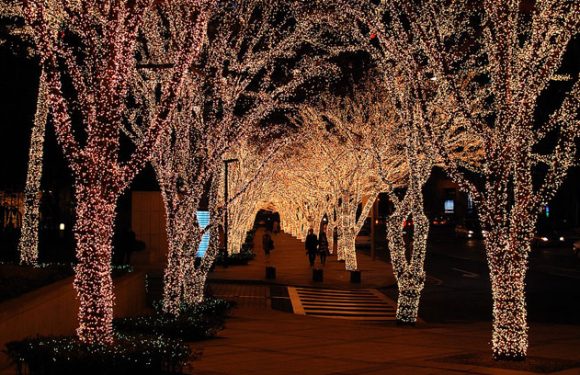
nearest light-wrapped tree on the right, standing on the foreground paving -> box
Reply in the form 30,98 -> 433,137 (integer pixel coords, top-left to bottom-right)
406,1 -> 580,359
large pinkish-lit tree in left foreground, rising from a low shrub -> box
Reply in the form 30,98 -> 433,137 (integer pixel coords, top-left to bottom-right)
24,1 -> 208,343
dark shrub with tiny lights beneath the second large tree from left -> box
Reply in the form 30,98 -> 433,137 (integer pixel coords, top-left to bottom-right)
113,298 -> 234,341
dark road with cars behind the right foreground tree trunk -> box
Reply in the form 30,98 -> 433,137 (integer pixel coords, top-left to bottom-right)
362,228 -> 580,324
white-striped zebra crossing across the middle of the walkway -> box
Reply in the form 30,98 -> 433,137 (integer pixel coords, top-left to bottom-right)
288,287 -> 396,321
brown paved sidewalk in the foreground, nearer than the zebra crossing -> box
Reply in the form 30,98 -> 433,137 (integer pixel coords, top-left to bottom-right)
192,302 -> 580,375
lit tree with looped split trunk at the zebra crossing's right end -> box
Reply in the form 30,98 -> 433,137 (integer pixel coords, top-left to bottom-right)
312,86 -> 432,323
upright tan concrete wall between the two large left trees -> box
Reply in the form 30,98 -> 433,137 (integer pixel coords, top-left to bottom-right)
131,191 -> 167,268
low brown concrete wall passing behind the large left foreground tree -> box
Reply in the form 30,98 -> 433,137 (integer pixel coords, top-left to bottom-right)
0,272 -> 147,368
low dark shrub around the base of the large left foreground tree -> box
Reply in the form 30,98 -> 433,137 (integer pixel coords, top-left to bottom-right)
6,335 -> 199,375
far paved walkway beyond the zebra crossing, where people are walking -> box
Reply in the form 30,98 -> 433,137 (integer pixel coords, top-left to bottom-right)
209,228 -> 395,289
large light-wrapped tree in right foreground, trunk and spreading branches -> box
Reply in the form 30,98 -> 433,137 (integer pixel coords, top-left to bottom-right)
328,0 -> 580,359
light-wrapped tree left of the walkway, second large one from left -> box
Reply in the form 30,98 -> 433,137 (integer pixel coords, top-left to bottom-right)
125,1 -> 340,314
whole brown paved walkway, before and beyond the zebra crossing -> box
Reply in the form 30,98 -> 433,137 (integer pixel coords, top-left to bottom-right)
197,231 -> 580,375
